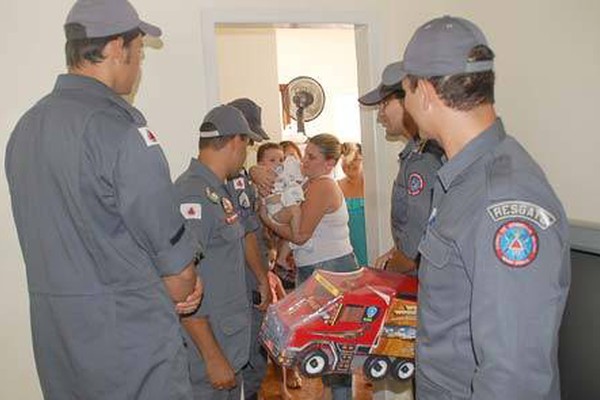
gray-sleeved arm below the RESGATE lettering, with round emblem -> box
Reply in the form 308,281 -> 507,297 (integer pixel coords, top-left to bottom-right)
471,205 -> 570,400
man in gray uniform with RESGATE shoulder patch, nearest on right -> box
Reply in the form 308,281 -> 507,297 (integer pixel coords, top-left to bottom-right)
389,17 -> 570,400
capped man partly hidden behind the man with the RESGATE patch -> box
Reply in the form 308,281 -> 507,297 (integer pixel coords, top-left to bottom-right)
358,66 -> 443,275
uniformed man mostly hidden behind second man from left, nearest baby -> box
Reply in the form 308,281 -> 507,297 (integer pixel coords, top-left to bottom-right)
227,98 -> 272,400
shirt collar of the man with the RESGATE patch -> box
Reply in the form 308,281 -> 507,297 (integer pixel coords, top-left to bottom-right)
438,118 -> 506,190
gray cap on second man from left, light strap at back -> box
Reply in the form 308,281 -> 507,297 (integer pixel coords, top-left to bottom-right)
200,106 -> 262,141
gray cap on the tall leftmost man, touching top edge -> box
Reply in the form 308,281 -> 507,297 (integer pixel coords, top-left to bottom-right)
65,0 -> 162,40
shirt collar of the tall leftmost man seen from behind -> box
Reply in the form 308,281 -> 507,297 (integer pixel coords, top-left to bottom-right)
54,74 -> 146,126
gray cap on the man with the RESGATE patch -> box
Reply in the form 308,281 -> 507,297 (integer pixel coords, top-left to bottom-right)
383,15 -> 494,85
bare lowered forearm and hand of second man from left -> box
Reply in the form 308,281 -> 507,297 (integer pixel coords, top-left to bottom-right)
181,317 -> 236,390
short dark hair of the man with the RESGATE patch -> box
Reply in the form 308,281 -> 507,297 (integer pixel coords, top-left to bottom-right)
407,45 -> 495,111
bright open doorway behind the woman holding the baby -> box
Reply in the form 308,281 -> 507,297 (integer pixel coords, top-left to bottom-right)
209,21 -> 380,264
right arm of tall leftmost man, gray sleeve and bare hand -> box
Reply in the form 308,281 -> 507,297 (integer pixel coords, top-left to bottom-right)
112,129 -> 202,313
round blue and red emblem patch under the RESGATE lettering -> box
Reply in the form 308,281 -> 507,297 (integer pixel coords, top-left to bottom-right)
494,221 -> 538,268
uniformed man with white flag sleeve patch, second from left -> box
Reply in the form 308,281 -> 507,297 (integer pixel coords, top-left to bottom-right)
175,106 -> 256,400
